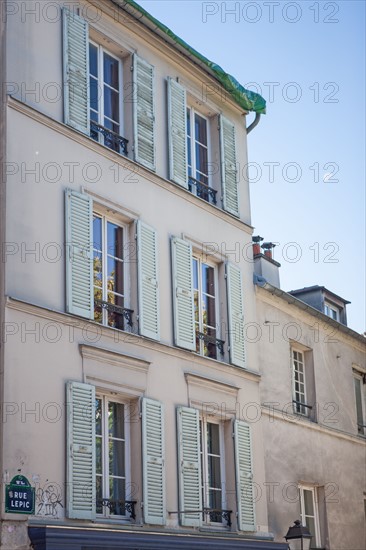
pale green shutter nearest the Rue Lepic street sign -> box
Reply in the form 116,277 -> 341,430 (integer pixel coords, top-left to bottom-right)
66,382 -> 96,519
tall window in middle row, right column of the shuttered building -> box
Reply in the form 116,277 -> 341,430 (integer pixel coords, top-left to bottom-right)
193,258 -> 217,359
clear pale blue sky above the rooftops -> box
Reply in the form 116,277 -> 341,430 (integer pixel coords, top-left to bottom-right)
139,0 -> 366,332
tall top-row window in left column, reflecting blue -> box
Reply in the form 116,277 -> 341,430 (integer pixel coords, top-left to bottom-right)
89,42 -> 121,152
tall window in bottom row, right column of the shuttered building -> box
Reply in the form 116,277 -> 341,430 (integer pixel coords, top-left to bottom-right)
200,418 -> 223,523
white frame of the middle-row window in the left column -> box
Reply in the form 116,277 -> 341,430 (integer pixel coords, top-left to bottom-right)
93,210 -> 131,330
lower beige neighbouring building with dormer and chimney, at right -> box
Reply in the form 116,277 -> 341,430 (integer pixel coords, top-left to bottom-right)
254,253 -> 366,550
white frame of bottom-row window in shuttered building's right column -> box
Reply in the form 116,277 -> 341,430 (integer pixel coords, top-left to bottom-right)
199,414 -> 227,527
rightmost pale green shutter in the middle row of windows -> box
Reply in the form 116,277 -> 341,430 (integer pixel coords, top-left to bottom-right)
226,263 -> 245,367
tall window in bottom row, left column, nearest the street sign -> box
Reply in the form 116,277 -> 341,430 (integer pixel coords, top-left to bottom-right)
95,395 -> 128,516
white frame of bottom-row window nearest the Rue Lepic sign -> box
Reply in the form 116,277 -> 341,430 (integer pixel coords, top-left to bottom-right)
95,390 -> 131,520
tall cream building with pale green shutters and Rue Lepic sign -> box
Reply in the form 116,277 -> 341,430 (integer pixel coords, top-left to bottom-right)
0,0 -> 285,550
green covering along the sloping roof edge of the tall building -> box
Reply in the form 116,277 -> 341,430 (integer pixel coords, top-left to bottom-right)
114,0 -> 266,114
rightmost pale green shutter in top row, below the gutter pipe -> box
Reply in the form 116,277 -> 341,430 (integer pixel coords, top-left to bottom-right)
220,115 -> 239,216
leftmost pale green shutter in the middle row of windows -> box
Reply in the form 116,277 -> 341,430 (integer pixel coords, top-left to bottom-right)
65,189 -> 94,319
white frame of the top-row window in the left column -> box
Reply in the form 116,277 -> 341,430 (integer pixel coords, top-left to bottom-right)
88,40 -> 124,145
